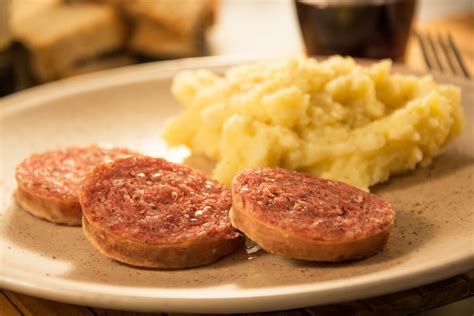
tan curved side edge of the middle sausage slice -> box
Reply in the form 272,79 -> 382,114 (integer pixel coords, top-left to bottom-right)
82,216 -> 244,269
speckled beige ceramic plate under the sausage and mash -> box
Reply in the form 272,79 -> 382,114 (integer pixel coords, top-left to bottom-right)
0,58 -> 474,313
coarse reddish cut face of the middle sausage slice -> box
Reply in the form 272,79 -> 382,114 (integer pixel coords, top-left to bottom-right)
81,157 -> 240,244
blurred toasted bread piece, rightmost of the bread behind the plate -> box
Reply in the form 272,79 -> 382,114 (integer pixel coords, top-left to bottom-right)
124,0 -> 217,58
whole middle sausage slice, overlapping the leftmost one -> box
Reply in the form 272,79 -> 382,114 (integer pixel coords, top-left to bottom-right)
80,157 -> 243,268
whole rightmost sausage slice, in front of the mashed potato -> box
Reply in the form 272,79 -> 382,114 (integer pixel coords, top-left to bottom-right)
230,168 -> 395,261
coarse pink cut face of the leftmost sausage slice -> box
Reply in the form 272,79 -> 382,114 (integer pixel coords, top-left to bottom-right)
16,145 -> 138,201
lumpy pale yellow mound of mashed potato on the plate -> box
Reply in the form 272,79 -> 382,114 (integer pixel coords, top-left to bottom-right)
164,56 -> 463,190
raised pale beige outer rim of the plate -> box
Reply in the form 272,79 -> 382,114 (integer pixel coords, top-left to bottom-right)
0,56 -> 474,313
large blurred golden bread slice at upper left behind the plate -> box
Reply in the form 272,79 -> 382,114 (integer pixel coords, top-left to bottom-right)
12,3 -> 125,82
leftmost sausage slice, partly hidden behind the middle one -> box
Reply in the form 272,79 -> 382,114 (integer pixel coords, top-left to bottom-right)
14,145 -> 133,225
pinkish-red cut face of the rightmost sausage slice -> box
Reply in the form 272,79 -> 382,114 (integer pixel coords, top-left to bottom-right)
232,168 -> 395,242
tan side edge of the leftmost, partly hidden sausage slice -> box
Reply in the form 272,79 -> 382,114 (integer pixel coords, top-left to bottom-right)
14,185 -> 82,226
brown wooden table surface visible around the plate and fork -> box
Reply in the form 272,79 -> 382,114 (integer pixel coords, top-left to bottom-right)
0,14 -> 474,316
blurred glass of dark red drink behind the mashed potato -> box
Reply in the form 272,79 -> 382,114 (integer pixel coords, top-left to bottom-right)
296,0 -> 416,61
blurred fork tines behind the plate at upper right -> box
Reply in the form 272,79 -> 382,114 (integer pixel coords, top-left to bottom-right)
415,32 -> 471,78
